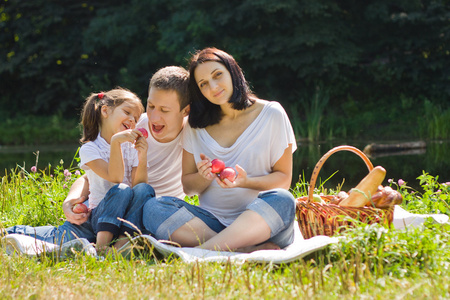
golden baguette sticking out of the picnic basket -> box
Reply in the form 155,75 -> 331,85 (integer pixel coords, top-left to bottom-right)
339,166 -> 386,207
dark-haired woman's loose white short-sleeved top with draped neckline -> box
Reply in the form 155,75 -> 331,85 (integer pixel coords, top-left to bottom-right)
183,101 -> 297,226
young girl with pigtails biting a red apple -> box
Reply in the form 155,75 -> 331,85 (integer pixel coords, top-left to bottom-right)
80,88 -> 148,251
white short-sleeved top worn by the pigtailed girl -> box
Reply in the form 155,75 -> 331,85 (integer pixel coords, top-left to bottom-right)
80,133 -> 139,209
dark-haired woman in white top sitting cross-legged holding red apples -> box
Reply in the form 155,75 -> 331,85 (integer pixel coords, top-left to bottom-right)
144,48 -> 296,251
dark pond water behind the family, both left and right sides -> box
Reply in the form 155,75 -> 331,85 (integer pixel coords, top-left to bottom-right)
0,141 -> 450,191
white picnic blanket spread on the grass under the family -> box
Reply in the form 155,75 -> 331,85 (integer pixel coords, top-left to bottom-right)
1,205 -> 449,264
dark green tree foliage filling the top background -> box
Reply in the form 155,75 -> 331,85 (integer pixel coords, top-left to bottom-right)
0,0 -> 450,122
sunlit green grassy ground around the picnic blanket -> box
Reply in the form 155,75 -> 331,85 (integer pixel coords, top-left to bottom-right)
0,163 -> 450,299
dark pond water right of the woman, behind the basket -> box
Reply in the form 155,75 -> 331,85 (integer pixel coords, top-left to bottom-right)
293,141 -> 450,191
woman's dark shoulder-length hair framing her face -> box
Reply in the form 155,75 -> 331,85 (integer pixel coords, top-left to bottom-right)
189,48 -> 255,128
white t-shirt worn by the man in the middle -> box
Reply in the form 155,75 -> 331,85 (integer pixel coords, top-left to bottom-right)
136,113 -> 187,199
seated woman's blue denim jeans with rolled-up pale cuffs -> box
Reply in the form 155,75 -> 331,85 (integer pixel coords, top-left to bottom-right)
142,189 -> 295,248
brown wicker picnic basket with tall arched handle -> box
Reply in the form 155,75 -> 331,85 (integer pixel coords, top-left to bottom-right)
296,145 -> 393,239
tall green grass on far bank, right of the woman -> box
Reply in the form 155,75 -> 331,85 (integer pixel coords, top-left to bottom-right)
285,93 -> 450,141
